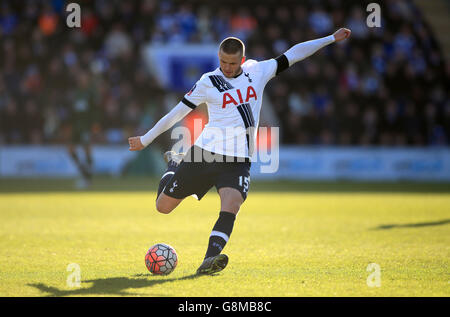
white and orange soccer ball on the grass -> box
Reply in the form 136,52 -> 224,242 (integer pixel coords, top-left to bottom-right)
145,243 -> 178,275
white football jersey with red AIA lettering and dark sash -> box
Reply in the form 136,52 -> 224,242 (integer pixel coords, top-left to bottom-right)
182,59 -> 277,158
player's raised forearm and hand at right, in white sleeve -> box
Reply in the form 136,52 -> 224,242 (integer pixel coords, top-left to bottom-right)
283,28 -> 351,67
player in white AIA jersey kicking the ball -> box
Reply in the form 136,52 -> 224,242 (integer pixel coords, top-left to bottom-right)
128,28 -> 351,274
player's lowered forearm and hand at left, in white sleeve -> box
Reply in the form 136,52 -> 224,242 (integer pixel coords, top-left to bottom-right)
128,102 -> 192,151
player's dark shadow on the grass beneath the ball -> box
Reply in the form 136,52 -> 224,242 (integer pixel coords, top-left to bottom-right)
27,274 -> 201,297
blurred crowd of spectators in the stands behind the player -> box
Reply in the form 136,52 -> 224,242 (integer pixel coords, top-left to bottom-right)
0,0 -> 450,146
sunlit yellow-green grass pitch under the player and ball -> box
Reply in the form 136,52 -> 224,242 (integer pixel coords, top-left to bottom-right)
0,178 -> 450,297
